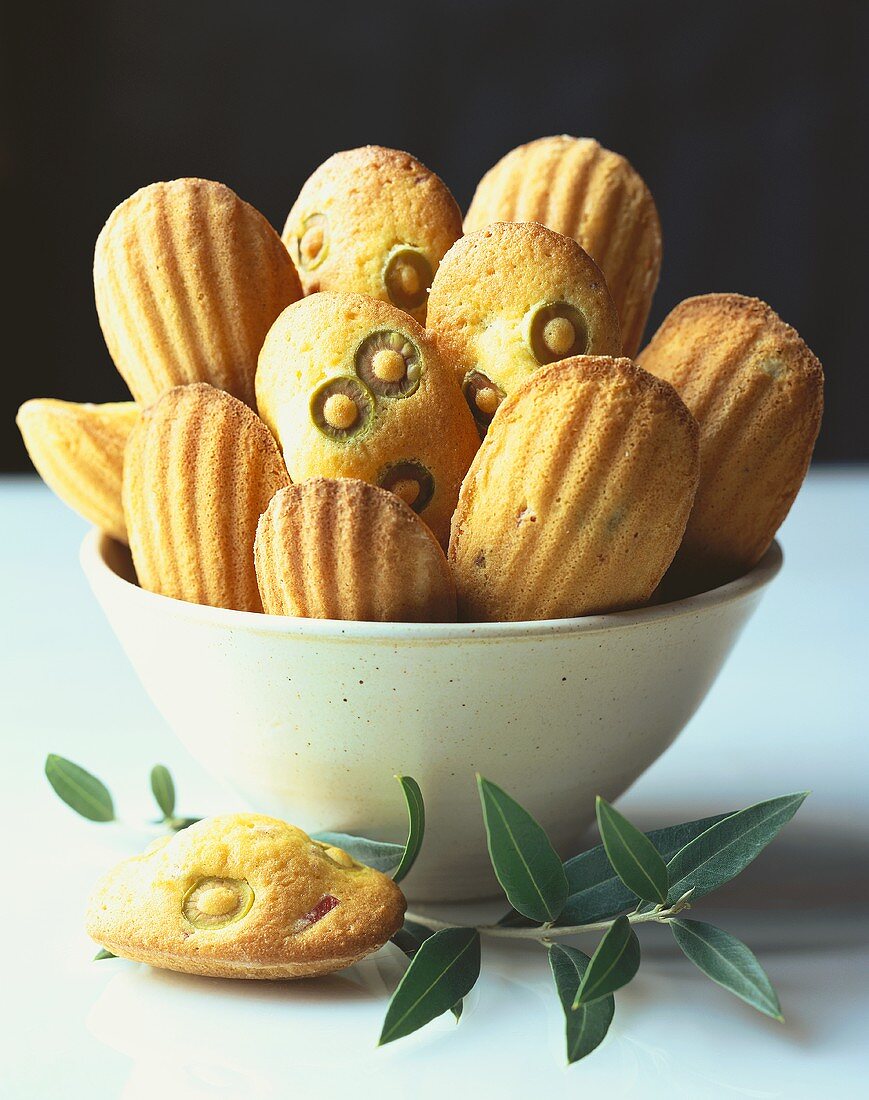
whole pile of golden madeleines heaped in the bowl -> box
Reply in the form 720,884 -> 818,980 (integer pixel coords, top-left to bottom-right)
18,136 -> 823,622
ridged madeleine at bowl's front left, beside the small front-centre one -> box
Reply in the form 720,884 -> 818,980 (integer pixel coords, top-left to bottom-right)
123,382 -> 289,612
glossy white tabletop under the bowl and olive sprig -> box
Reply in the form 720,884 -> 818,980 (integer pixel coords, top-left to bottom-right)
0,471 -> 869,1100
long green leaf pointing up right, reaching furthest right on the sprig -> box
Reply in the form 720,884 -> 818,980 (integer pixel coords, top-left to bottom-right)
667,791 -> 809,904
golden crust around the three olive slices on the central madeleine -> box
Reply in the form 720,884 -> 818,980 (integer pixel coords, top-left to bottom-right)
256,293 -> 480,546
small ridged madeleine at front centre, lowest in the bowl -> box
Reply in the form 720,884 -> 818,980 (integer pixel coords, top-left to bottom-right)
255,477 -> 455,623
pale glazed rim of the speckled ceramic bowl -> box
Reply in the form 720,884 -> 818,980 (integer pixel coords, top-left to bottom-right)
79,528 -> 783,641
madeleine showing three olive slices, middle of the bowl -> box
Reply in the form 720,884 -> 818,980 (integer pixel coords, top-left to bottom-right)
256,293 -> 480,546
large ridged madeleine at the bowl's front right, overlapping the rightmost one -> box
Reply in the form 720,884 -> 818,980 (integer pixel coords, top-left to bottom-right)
450,356 -> 700,620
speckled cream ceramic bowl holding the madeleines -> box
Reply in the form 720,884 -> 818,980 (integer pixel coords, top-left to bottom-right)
81,531 -> 782,901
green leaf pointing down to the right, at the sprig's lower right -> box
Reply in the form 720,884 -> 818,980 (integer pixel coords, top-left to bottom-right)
669,917 -> 784,1023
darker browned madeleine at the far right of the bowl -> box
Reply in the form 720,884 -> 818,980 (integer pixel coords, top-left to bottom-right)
639,294 -> 824,591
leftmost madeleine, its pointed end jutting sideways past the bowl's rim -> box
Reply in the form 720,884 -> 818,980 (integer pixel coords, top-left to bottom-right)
17,398 -> 139,542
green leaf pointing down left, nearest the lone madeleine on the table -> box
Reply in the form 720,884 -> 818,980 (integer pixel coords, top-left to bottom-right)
380,928 -> 480,1046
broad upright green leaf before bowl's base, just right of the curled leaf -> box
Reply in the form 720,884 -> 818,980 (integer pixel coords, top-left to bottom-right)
476,776 -> 568,923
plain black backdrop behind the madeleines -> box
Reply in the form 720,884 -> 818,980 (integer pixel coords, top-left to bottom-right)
0,0 -> 869,470
